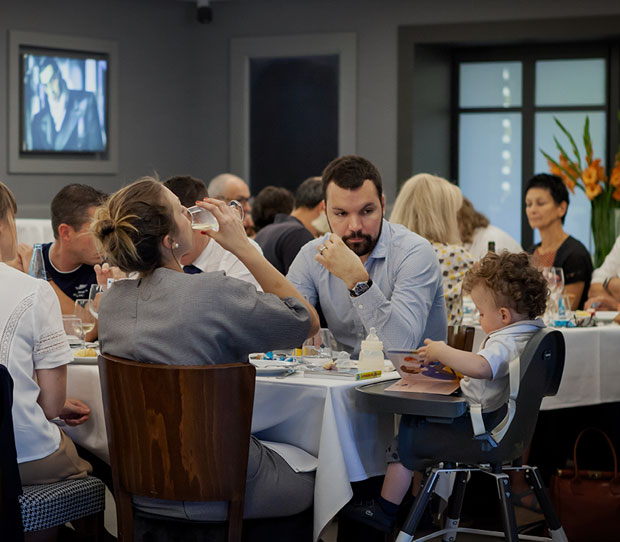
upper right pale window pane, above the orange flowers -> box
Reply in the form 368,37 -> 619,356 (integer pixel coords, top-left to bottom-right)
536,58 -> 606,106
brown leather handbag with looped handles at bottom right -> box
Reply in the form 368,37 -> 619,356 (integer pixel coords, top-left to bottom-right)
550,427 -> 620,542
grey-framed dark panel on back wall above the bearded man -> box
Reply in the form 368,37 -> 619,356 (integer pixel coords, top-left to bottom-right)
230,34 -> 356,194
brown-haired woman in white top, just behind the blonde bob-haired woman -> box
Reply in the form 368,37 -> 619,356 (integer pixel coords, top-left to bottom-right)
457,197 -> 523,260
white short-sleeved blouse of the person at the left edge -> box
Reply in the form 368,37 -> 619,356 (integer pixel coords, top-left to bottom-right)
0,263 -> 72,463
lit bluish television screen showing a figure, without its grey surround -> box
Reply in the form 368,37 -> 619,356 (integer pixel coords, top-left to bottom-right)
21,50 -> 108,153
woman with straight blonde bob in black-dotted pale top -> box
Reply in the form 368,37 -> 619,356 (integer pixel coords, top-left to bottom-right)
390,173 -> 474,325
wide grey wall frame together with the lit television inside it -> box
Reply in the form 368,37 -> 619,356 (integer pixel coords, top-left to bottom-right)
8,31 -> 118,174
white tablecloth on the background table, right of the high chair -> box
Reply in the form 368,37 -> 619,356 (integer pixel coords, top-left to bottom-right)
473,324 -> 620,410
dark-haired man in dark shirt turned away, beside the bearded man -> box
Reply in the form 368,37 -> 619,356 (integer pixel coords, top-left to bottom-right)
256,177 -> 325,275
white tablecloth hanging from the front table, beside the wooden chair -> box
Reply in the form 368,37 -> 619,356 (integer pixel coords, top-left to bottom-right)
64,364 -> 396,540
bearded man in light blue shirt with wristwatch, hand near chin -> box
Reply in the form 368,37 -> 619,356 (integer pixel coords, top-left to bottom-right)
287,156 -> 447,354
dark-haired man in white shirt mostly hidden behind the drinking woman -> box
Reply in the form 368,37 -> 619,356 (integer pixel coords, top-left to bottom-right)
164,175 -> 262,292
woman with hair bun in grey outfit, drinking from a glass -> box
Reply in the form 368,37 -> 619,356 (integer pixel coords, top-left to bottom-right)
92,177 -> 319,520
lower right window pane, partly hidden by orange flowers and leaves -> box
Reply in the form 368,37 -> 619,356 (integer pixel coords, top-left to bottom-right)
534,111 -> 606,251
